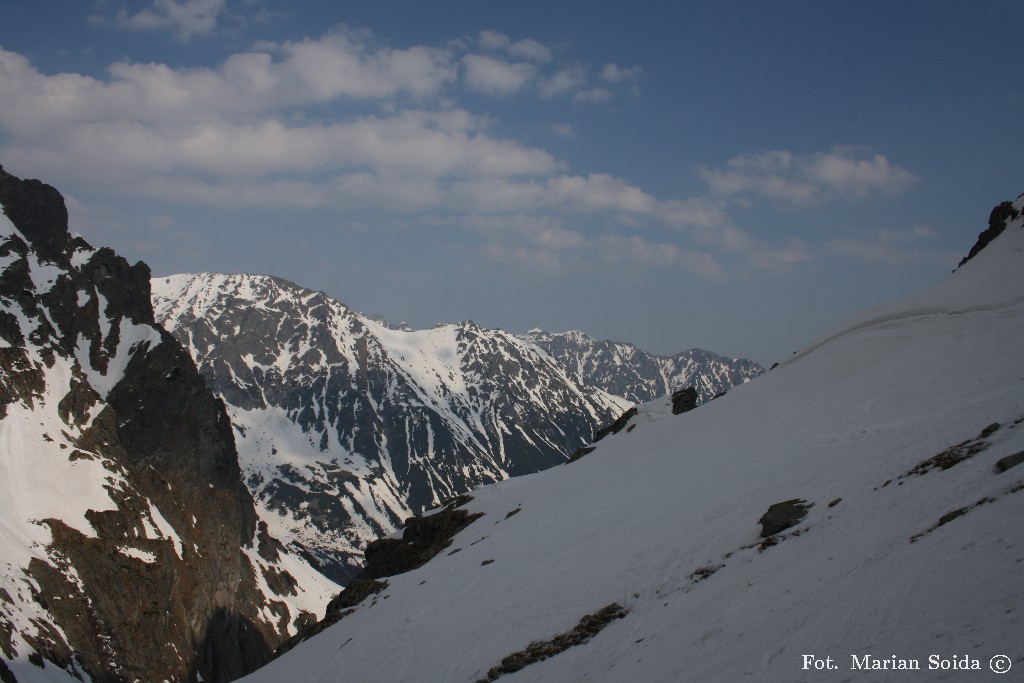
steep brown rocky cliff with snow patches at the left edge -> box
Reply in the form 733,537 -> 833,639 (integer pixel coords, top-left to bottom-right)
0,169 -> 332,683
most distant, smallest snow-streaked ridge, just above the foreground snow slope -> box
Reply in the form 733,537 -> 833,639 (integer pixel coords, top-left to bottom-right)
521,329 -> 764,403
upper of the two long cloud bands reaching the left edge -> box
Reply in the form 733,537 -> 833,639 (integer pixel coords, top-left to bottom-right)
0,31 -> 458,133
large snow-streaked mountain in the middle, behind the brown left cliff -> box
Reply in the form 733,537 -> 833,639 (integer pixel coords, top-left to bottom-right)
153,273 -> 629,583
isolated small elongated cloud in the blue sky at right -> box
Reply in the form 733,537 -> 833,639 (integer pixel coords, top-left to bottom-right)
698,147 -> 916,206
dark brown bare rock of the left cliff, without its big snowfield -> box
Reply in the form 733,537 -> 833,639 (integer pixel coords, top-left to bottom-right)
0,169 -> 294,683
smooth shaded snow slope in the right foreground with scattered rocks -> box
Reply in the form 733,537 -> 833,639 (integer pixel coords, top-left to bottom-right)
237,194 -> 1024,683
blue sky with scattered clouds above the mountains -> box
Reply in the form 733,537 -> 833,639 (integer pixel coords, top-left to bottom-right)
0,0 -> 1024,366
